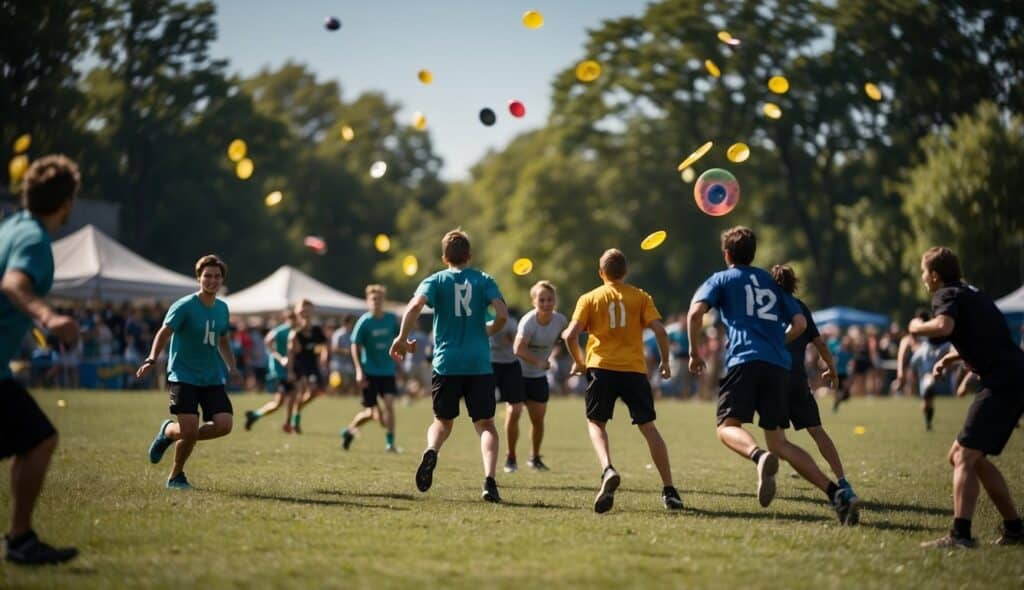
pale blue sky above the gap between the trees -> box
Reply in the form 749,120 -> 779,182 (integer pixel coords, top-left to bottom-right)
213,0 -> 647,179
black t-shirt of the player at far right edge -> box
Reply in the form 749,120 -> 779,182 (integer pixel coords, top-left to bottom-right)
932,283 -> 1024,393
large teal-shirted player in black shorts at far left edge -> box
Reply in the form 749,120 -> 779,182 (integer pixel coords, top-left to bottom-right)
0,156 -> 80,565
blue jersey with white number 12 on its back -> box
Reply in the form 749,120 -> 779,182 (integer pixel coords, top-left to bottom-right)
693,266 -> 801,371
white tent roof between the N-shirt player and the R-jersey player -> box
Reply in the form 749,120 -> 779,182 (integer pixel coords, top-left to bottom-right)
224,266 -> 367,314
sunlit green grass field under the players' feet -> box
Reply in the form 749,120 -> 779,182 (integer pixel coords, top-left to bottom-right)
0,391 -> 1024,589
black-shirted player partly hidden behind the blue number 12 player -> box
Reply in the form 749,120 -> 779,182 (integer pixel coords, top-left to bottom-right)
771,264 -> 859,512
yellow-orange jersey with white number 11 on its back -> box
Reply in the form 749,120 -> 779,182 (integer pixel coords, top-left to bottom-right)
572,283 -> 662,375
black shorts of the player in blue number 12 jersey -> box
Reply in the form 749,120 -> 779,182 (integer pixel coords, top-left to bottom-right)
718,361 -> 790,430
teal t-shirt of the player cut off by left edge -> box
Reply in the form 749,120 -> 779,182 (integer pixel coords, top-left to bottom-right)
0,211 -> 53,379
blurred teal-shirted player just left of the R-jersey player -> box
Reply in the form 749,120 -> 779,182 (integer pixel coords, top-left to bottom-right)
341,285 -> 398,453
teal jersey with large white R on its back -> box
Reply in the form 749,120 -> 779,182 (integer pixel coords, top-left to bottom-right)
416,268 -> 502,375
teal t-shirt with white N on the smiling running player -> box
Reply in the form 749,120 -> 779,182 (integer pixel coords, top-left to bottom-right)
164,293 -> 228,385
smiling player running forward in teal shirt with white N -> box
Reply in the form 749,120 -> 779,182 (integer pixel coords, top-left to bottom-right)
135,254 -> 241,490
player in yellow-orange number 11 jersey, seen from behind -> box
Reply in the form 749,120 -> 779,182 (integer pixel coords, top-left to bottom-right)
562,249 -> 683,514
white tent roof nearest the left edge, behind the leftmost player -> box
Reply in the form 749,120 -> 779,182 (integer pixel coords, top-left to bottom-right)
50,225 -> 199,301
